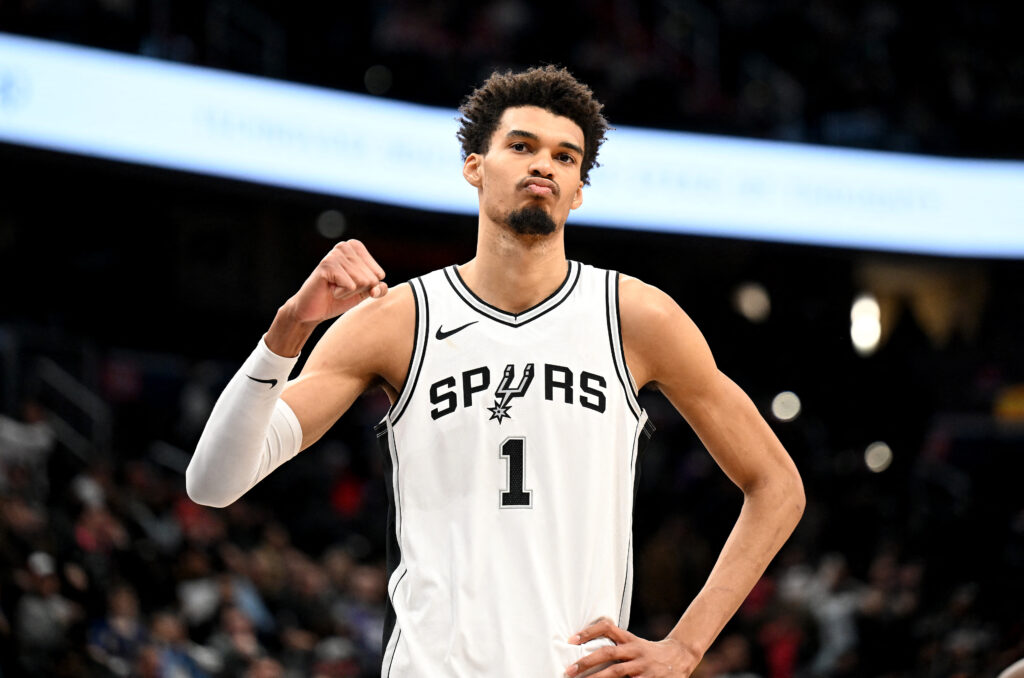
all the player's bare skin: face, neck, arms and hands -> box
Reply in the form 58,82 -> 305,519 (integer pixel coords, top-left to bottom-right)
260,107 -> 804,678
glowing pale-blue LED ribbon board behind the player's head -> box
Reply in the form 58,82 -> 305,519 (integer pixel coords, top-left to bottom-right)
6,34 -> 1024,258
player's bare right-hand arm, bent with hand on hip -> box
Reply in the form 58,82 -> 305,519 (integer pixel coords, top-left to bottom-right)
566,279 -> 804,678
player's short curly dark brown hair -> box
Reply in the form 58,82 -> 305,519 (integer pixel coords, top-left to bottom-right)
456,66 -> 608,184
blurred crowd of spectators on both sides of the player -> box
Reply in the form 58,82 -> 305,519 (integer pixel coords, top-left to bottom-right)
0,365 -> 1024,678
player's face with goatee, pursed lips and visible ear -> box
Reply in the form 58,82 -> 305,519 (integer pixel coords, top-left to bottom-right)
463,105 -> 584,235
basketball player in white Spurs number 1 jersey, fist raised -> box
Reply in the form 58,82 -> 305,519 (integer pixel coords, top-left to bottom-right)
186,67 -> 804,678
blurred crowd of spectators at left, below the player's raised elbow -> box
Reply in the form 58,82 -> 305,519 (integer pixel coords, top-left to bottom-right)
0,395 -> 385,678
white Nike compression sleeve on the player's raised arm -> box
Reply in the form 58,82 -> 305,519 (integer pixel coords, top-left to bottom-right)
185,339 -> 302,508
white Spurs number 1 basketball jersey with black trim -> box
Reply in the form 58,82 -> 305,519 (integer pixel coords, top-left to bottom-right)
377,261 -> 653,678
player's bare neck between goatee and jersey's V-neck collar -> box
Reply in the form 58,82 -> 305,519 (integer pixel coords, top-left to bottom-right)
459,219 -> 567,313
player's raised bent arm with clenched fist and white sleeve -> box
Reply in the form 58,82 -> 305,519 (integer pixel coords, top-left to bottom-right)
185,241 -> 415,507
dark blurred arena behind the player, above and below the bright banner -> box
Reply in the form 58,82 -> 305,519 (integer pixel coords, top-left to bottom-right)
0,0 -> 1024,678
